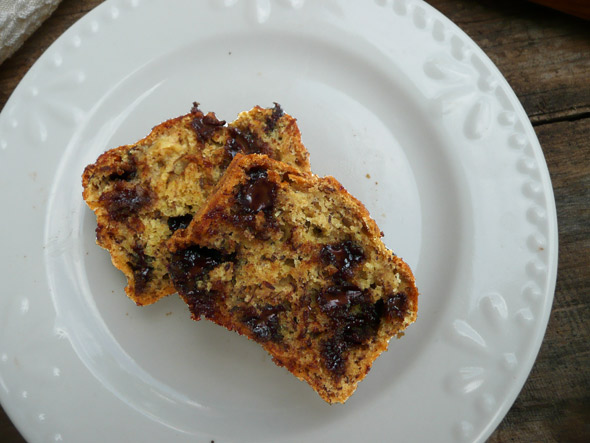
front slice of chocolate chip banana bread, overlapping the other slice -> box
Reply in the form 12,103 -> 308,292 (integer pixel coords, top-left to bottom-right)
168,155 -> 418,403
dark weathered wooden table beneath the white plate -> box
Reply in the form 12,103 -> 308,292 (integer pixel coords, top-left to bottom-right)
0,0 -> 590,443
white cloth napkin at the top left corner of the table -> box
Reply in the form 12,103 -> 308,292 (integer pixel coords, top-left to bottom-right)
0,0 -> 61,64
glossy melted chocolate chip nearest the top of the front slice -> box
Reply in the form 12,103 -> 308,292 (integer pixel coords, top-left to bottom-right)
236,168 -> 277,214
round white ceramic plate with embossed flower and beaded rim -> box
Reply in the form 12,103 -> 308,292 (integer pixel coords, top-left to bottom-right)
0,0 -> 557,443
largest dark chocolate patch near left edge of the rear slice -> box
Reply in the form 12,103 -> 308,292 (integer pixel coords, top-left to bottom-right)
98,181 -> 152,221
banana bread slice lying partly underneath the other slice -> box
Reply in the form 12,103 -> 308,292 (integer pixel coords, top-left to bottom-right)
82,103 -> 309,305
